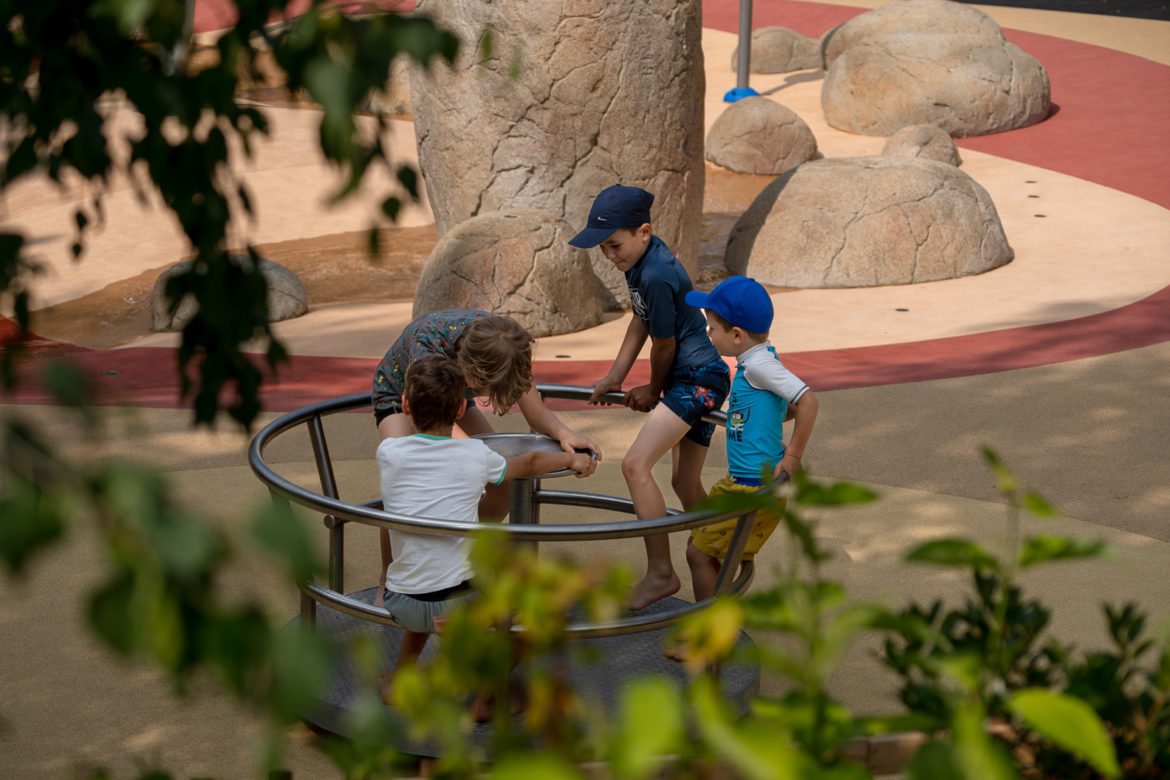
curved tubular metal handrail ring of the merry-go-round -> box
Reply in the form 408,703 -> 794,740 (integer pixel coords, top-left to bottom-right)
248,385 -> 755,637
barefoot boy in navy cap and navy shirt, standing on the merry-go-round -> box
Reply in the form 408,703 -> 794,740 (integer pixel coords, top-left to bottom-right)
569,185 -> 730,609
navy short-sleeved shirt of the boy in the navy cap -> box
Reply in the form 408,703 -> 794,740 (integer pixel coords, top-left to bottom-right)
626,236 -> 720,382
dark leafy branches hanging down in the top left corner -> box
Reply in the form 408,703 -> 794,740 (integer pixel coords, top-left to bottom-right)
0,0 -> 457,426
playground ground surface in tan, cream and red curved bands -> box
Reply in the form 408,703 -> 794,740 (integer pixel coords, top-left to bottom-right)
0,0 -> 1170,778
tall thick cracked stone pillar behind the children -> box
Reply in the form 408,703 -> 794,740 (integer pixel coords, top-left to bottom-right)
412,0 -> 704,280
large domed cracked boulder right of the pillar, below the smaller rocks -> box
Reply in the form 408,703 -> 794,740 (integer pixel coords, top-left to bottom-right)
727,157 -> 1012,288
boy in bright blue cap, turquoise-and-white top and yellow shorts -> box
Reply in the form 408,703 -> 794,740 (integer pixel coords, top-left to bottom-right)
687,276 -> 819,601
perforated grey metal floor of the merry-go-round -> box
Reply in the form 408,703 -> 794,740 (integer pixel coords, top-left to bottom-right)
288,588 -> 759,757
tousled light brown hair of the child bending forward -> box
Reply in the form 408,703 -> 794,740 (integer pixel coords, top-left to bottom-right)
455,316 -> 536,414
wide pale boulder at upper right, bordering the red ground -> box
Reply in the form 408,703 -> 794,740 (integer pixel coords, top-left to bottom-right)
821,33 -> 1049,137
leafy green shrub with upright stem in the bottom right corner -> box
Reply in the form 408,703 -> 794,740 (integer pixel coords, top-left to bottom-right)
885,448 -> 1170,778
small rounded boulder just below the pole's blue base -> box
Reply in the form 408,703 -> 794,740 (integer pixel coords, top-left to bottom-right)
707,97 -> 817,175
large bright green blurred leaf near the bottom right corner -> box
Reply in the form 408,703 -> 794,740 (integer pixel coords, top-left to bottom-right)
1007,688 -> 1121,778
